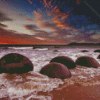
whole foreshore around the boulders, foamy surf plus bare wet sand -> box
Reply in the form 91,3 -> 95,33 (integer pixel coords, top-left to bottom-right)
0,47 -> 100,100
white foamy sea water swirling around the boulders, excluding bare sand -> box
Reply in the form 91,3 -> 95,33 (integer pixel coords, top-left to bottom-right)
0,47 -> 100,100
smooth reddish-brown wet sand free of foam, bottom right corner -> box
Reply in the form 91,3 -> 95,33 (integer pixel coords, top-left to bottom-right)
38,85 -> 100,100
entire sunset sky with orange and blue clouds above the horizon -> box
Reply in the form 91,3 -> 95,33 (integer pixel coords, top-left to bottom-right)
0,0 -> 100,45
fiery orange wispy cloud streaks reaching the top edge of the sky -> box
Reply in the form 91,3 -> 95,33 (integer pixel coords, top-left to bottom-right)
43,0 -> 71,29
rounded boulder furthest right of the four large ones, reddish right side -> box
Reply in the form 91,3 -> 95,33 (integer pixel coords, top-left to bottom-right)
76,56 -> 100,68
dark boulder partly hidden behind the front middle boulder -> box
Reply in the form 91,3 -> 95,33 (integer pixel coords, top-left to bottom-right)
50,56 -> 76,69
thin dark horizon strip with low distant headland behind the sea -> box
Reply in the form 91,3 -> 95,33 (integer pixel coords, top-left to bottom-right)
0,42 -> 100,48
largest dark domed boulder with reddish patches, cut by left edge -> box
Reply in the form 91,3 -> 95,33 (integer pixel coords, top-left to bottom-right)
0,53 -> 33,74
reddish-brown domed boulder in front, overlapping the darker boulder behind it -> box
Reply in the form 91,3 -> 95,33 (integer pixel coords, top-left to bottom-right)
40,62 -> 71,79
